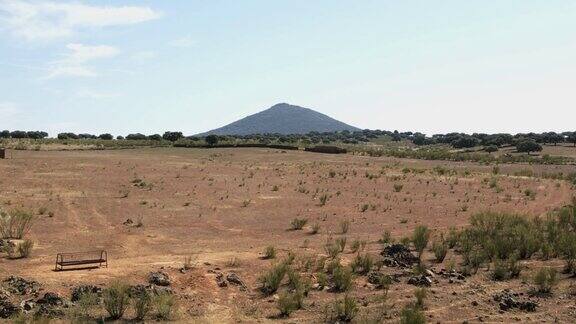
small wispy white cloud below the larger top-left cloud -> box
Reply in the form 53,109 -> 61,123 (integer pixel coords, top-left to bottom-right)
45,43 -> 120,79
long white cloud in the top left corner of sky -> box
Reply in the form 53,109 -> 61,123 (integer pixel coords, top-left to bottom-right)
0,0 -> 162,41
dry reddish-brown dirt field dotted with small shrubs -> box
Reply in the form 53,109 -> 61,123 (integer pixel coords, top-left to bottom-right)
0,148 -> 576,323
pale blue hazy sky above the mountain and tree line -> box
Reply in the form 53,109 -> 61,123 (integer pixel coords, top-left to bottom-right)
0,0 -> 576,135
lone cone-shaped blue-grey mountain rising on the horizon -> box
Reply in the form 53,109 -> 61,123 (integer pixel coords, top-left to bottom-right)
200,103 -> 360,136
